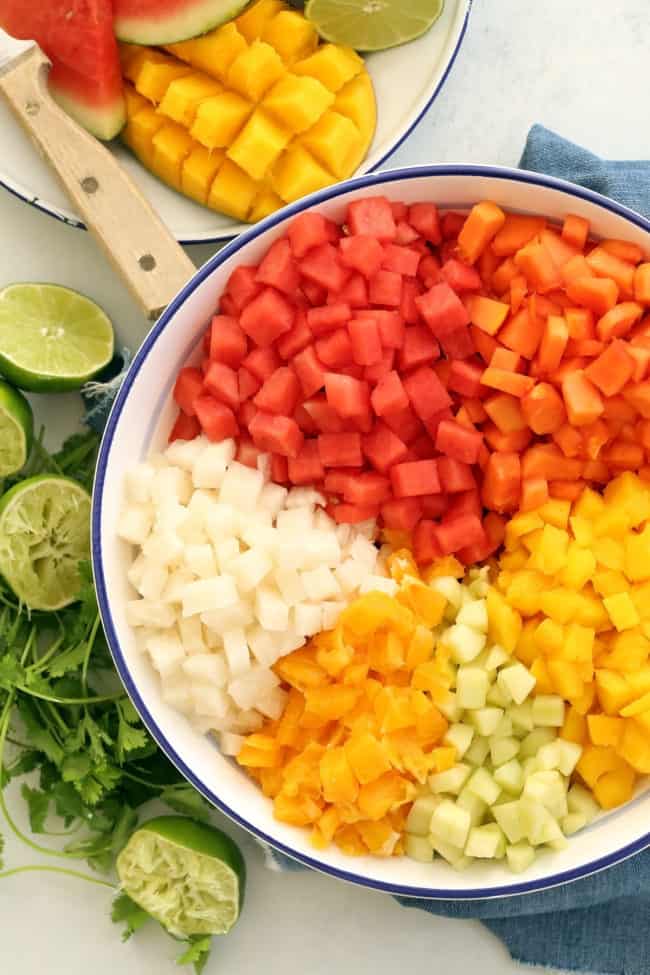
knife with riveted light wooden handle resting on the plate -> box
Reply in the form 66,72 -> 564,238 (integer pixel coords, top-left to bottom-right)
0,32 -> 196,321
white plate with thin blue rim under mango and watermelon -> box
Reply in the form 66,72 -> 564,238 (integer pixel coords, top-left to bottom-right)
0,0 -> 472,244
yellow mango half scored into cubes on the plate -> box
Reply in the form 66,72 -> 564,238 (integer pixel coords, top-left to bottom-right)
121,0 -> 376,223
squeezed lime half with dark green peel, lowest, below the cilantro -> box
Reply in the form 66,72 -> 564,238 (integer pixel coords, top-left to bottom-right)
117,816 -> 246,938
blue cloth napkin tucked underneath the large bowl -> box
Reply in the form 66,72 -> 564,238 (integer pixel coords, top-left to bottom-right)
84,125 -> 650,975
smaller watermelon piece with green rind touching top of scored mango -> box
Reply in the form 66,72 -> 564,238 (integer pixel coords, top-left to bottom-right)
113,0 -> 248,44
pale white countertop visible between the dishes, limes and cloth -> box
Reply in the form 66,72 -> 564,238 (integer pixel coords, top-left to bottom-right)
0,0 -> 650,975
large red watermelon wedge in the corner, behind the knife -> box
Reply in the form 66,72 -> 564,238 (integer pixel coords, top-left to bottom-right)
0,0 -> 126,139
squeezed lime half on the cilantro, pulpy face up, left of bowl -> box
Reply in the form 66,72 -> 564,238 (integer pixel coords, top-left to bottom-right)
0,474 -> 90,610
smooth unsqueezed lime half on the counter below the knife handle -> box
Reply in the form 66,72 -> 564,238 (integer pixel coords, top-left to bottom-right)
0,284 -> 113,393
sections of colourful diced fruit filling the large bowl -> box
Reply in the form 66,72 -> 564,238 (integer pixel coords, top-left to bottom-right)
119,196 -> 650,872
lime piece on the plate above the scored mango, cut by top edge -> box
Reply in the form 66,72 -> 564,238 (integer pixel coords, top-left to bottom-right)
305,0 -> 444,51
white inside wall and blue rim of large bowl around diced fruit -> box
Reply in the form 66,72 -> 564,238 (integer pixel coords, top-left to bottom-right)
92,166 -> 650,900
